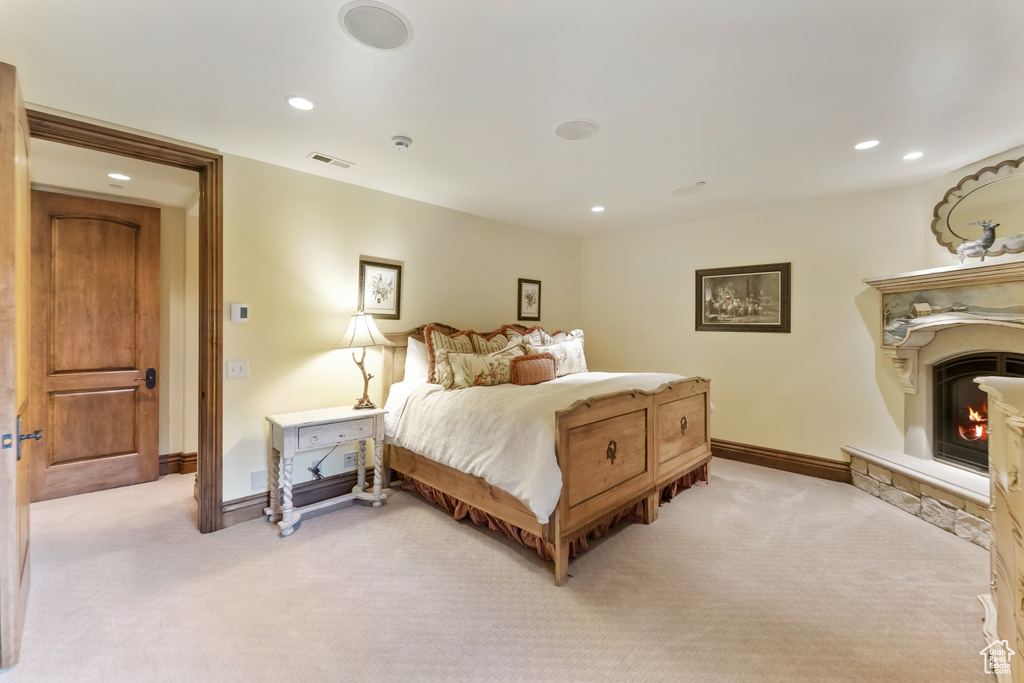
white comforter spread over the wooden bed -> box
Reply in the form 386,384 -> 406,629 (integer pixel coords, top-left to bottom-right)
386,373 -> 682,523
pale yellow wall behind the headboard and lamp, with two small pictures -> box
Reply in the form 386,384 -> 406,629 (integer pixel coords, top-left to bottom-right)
224,156 -> 581,500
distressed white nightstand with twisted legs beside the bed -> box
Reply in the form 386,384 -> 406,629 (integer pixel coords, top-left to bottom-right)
263,408 -> 387,537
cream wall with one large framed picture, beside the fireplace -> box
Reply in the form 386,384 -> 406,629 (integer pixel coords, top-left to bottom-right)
582,146 -> 1020,460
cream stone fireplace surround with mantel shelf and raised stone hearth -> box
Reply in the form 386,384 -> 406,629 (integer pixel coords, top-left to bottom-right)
843,261 -> 1024,548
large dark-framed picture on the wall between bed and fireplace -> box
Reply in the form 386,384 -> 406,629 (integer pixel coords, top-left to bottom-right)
695,263 -> 790,332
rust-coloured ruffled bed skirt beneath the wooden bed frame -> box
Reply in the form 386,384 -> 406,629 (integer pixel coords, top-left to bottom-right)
401,464 -> 708,560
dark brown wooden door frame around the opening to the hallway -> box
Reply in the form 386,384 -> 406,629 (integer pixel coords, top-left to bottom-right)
26,109 -> 224,533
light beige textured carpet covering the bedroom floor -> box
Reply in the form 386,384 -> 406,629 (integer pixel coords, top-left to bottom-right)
0,460 -> 990,683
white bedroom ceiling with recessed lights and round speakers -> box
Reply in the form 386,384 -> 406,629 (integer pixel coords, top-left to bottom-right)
0,0 -> 1024,237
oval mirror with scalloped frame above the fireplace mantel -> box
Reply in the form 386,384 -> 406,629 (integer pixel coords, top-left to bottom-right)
932,154 -> 1024,262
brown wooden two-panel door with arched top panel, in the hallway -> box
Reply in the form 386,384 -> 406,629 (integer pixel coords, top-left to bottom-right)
32,191 -> 160,501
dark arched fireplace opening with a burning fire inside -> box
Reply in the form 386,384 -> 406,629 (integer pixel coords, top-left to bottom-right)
934,353 -> 1024,473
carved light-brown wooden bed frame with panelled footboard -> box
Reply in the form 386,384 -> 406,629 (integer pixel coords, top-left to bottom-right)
383,324 -> 711,586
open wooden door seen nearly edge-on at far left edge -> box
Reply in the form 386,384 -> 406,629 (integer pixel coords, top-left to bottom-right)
0,63 -> 36,669
